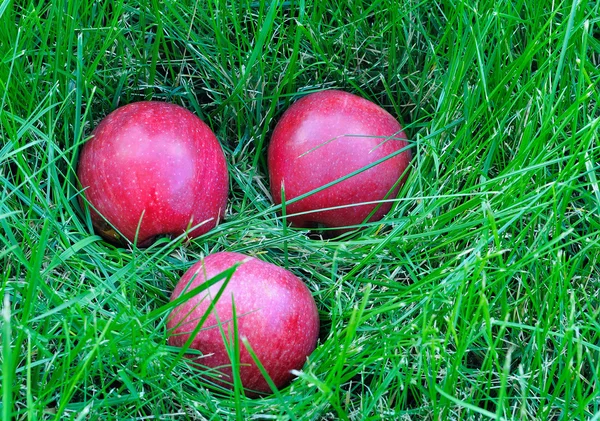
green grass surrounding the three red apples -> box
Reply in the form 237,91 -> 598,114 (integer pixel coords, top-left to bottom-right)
0,0 -> 600,420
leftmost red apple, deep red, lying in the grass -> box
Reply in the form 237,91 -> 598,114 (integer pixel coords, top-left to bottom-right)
77,101 -> 229,247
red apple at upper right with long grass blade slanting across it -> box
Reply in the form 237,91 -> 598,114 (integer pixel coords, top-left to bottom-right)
268,90 -> 411,232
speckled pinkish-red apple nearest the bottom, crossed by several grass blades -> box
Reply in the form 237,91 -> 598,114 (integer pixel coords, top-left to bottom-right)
167,252 -> 319,397
